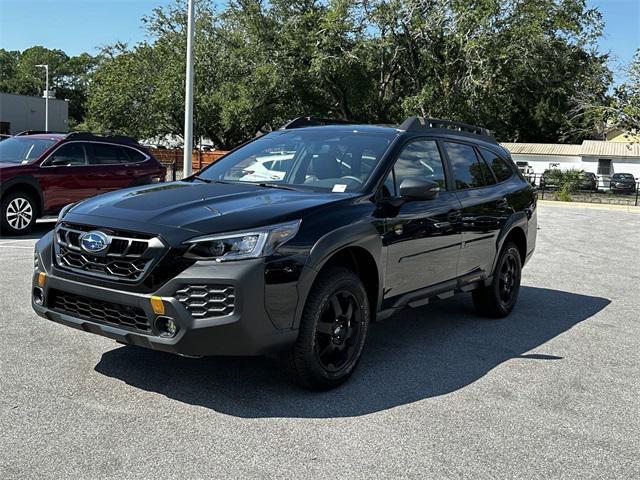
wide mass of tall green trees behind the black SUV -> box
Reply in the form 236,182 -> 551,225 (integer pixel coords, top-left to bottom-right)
89,0 -> 611,147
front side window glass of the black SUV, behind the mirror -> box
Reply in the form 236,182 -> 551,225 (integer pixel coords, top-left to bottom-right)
393,140 -> 446,192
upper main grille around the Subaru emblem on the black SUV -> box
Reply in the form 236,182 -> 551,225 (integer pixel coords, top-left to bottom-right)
55,223 -> 165,282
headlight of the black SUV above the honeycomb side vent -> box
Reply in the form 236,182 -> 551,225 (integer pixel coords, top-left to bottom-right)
185,220 -> 300,262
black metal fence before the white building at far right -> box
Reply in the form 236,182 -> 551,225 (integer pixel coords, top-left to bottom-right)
524,173 -> 640,207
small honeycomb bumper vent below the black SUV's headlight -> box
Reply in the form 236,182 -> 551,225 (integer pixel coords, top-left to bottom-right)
175,285 -> 236,318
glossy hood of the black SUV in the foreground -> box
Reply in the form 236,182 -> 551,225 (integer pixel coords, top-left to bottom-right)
65,181 -> 355,234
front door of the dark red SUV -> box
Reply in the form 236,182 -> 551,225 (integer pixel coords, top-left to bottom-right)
40,142 -> 93,210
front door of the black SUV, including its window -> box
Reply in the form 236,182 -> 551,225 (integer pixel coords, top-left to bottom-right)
383,139 -> 461,298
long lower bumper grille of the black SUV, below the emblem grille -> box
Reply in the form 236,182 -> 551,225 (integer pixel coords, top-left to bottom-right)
49,289 -> 151,332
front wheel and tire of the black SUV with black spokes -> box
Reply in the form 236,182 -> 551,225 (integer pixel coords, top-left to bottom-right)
279,267 -> 370,390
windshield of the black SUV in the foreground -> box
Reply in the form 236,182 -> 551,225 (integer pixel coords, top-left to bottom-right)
198,131 -> 394,192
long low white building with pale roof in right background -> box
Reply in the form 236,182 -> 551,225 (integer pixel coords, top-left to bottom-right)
502,140 -> 640,187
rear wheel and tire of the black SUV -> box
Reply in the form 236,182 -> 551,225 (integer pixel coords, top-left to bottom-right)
472,242 -> 522,318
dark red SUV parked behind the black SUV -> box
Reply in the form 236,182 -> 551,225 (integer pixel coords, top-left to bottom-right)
0,131 -> 166,234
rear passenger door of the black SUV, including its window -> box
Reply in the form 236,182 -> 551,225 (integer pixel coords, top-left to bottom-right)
443,141 -> 510,277
